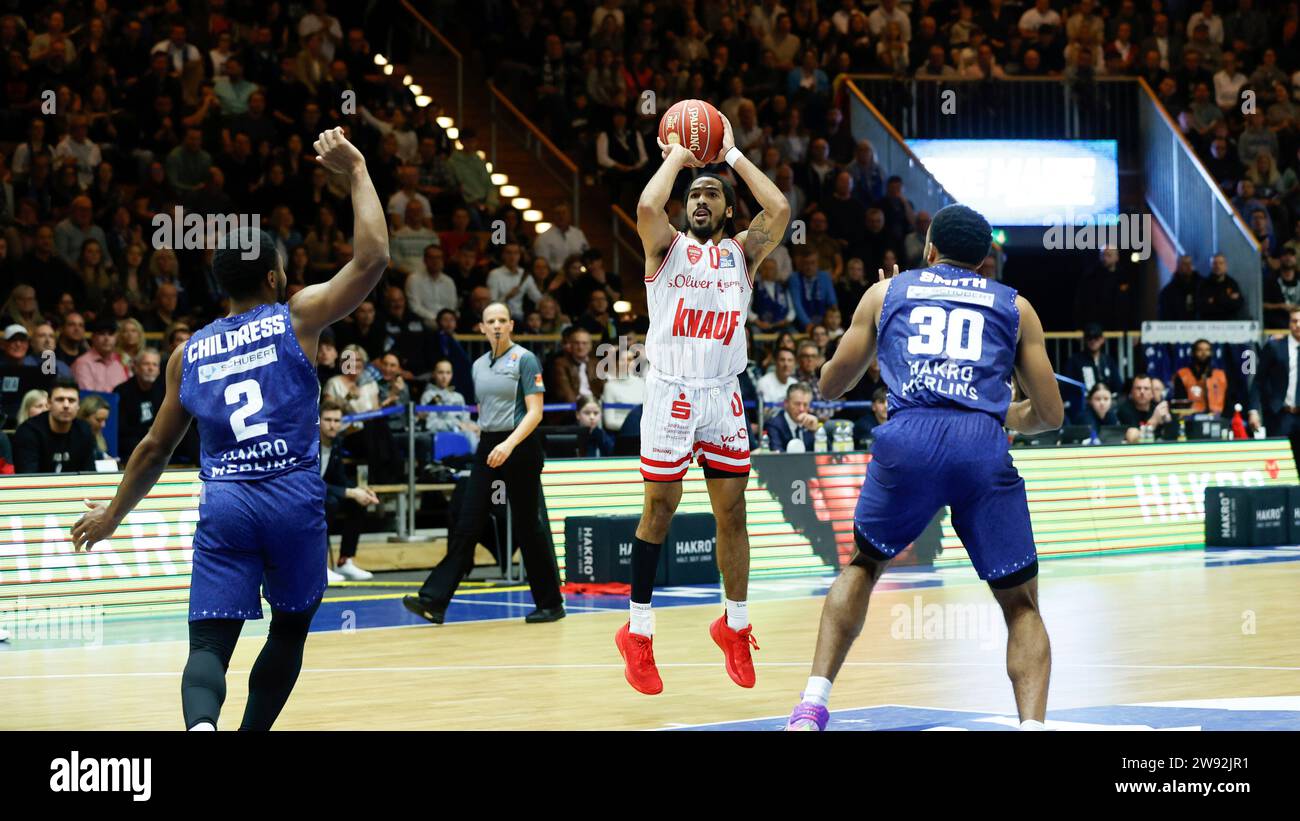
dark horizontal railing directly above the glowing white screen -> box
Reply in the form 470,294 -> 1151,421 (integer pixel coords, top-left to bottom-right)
837,74 -> 1139,162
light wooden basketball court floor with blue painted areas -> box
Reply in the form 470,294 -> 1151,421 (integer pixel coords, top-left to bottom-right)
0,548 -> 1300,730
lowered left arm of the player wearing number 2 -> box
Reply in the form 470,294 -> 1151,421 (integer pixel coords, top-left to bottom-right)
73,347 -> 190,551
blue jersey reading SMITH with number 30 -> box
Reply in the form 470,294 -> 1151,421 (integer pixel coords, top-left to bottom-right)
876,265 -> 1021,421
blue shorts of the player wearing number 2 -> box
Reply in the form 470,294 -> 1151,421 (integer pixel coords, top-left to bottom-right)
190,466 -> 328,621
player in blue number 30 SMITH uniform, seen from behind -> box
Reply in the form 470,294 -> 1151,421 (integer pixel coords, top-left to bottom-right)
787,205 -> 1065,730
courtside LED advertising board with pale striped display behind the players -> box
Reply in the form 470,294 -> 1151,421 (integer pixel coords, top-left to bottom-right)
0,439 -> 1297,614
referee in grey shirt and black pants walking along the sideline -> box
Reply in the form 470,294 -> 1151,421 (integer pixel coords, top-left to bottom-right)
402,303 -> 564,625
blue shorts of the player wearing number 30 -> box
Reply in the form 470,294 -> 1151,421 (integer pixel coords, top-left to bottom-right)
853,408 -> 1037,587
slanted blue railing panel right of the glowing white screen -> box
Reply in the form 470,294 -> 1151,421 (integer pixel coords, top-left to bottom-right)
1138,79 -> 1264,320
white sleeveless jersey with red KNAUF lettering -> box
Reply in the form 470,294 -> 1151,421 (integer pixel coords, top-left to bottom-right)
645,231 -> 754,379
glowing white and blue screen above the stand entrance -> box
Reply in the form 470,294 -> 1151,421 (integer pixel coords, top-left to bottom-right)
907,140 -> 1119,226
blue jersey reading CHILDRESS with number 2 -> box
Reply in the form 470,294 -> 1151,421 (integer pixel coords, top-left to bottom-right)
173,303 -> 320,482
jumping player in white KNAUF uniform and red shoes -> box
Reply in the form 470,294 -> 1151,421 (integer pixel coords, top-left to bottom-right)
615,117 -> 790,695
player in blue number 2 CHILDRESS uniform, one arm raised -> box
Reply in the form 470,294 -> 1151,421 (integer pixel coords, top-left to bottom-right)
73,129 -> 389,730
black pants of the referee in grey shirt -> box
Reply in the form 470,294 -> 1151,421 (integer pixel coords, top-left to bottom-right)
420,431 -> 564,609
